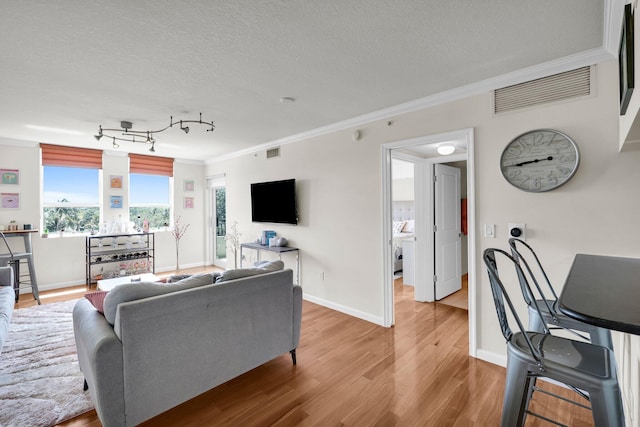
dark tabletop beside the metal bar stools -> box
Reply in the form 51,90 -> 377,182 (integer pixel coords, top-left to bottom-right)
558,254 -> 640,335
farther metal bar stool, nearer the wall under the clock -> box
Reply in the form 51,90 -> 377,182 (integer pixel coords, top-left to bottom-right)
509,238 -> 613,351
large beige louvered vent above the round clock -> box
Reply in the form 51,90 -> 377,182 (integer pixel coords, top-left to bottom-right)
493,67 -> 591,114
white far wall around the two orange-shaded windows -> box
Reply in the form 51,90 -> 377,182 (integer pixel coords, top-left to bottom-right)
0,143 -> 206,291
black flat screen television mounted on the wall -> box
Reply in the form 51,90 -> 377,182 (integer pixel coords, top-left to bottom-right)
251,179 -> 298,225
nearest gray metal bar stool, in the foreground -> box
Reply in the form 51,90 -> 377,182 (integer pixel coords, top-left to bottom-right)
483,248 -> 625,427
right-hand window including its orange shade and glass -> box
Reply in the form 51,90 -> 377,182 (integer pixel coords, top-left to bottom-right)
129,153 -> 173,229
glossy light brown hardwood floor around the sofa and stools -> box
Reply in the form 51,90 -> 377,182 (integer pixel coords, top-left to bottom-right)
19,269 -> 593,427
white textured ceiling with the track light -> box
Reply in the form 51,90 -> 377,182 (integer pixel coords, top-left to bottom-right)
0,0 -> 621,160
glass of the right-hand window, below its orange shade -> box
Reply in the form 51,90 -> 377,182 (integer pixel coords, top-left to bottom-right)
129,173 -> 171,229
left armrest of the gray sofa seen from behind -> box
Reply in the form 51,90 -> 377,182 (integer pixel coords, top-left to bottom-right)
73,298 -> 126,427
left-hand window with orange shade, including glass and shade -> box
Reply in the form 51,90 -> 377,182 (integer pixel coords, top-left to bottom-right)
41,144 -> 102,232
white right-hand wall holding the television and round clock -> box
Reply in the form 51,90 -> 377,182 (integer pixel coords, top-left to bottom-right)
207,61 -> 640,424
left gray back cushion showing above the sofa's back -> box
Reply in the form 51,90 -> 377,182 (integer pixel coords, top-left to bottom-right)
104,272 -> 218,325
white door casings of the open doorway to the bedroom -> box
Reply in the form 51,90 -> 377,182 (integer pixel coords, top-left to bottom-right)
381,129 -> 476,356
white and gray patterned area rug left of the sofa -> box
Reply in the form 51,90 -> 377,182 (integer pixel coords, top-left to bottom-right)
0,300 -> 93,427
